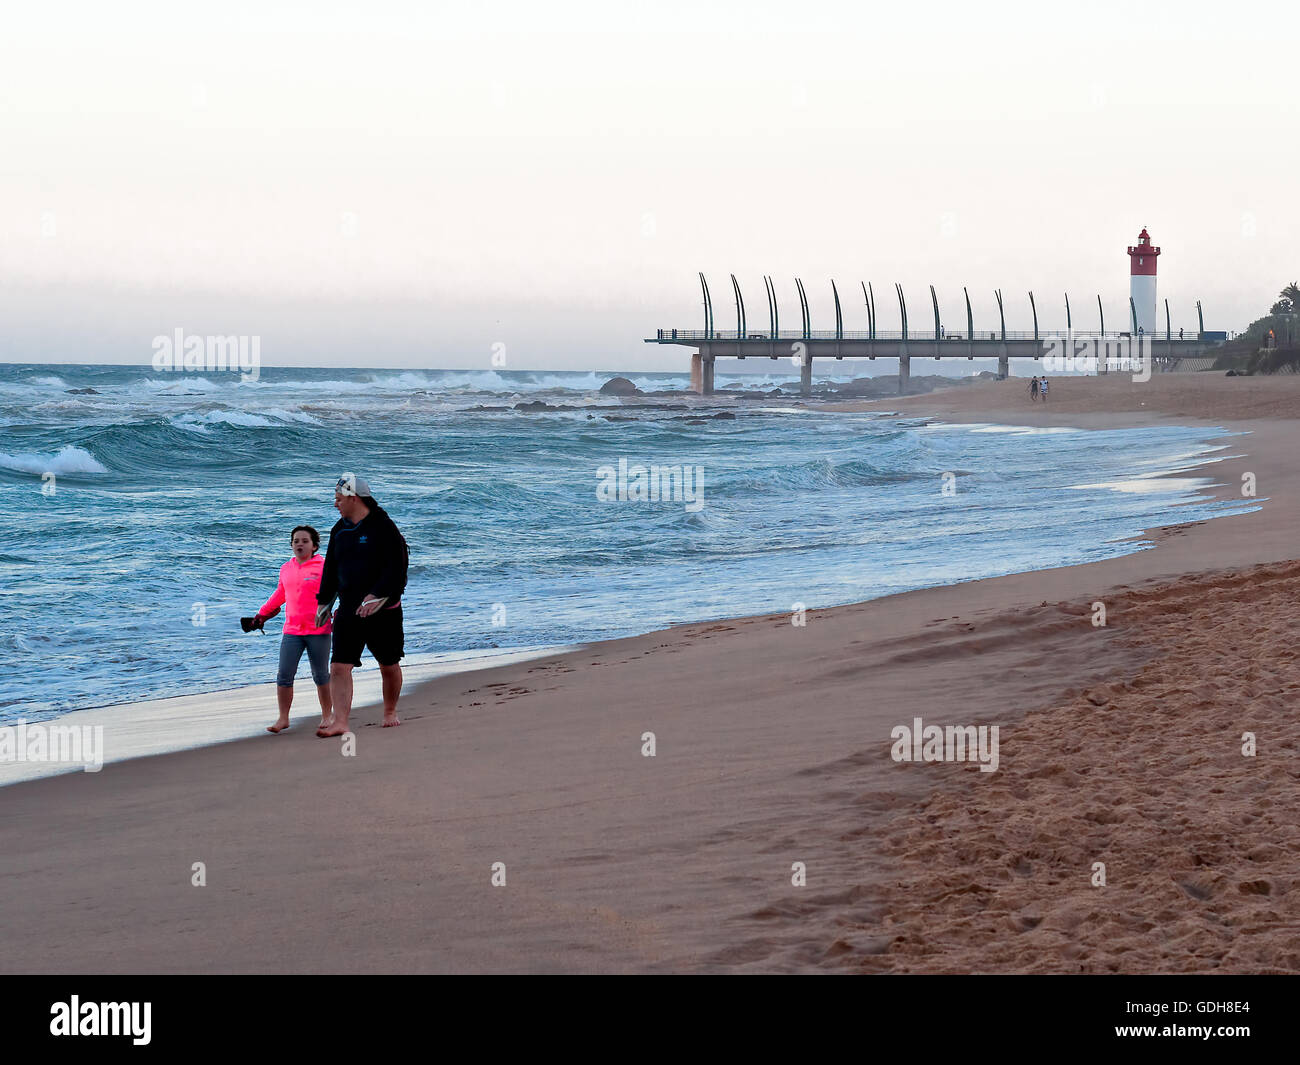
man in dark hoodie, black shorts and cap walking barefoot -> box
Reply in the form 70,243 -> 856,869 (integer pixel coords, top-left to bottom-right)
316,473 -> 408,736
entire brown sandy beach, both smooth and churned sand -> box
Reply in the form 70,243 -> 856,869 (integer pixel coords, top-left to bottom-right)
0,375 -> 1300,973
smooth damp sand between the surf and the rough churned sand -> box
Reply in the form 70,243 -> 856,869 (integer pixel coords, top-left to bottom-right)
0,378 -> 1300,973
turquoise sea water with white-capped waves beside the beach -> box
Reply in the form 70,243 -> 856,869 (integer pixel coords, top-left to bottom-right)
0,365 -> 1243,722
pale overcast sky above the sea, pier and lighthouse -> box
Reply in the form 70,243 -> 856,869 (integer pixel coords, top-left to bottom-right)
0,0 -> 1300,369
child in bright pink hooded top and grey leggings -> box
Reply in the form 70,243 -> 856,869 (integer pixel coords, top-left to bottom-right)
246,525 -> 334,732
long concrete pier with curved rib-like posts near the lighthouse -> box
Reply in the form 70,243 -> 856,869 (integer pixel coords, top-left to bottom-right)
645,274 -> 1227,395
